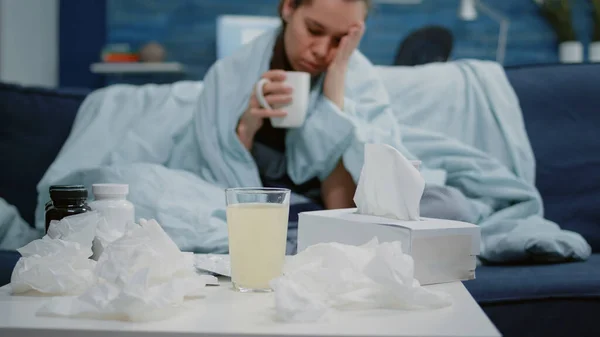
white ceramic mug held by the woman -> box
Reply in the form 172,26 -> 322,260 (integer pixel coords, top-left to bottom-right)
256,71 -> 310,128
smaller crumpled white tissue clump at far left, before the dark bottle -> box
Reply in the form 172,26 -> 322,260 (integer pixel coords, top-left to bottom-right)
11,212 -> 99,295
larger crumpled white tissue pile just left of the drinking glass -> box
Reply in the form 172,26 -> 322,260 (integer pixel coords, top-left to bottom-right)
38,220 -> 218,321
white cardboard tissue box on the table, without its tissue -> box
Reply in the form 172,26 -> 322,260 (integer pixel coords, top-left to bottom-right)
298,209 -> 481,285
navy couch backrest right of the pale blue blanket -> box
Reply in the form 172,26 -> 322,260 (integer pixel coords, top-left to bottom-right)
507,64 -> 600,252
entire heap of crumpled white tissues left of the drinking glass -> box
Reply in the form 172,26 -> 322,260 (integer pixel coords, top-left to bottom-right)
11,212 -> 218,321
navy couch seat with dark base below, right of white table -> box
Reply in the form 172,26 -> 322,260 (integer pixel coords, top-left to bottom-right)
464,254 -> 600,337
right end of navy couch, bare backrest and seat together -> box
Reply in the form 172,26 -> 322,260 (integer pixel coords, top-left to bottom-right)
465,64 -> 600,336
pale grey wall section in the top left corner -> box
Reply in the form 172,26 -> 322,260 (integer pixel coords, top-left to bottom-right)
0,0 -> 60,87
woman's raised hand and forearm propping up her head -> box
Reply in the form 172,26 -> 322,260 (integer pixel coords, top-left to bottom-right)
323,23 -> 365,110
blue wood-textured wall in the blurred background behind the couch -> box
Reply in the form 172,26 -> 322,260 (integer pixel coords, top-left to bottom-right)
107,0 -> 592,79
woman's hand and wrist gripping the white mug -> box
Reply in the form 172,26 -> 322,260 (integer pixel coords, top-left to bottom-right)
236,70 -> 292,150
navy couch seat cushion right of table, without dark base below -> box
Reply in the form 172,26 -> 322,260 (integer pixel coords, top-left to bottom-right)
465,254 -> 600,304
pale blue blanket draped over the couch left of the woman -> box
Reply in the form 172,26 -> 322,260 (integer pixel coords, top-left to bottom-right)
36,82 -> 234,252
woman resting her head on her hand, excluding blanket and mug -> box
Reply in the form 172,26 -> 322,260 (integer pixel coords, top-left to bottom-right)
237,0 -> 436,208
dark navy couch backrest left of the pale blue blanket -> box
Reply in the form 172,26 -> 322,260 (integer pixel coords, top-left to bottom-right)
0,83 -> 87,224
